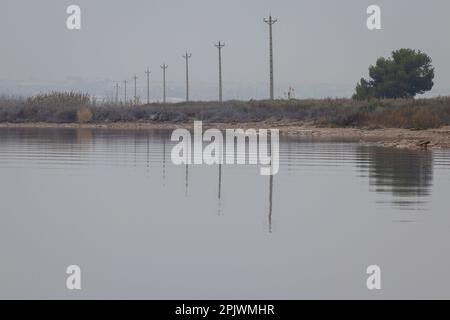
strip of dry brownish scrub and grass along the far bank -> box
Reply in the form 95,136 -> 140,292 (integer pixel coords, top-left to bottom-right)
0,92 -> 450,129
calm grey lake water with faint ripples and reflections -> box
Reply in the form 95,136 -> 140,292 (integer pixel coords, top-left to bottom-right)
0,129 -> 450,299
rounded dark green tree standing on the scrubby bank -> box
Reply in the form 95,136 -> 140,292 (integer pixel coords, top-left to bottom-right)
353,49 -> 434,100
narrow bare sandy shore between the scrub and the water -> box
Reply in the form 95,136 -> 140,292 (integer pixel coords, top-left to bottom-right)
0,121 -> 450,150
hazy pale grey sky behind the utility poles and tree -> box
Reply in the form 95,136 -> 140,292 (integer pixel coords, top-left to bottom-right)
0,0 -> 450,99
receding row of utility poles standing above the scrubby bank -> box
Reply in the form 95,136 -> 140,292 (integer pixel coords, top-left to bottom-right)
115,15 -> 278,105
